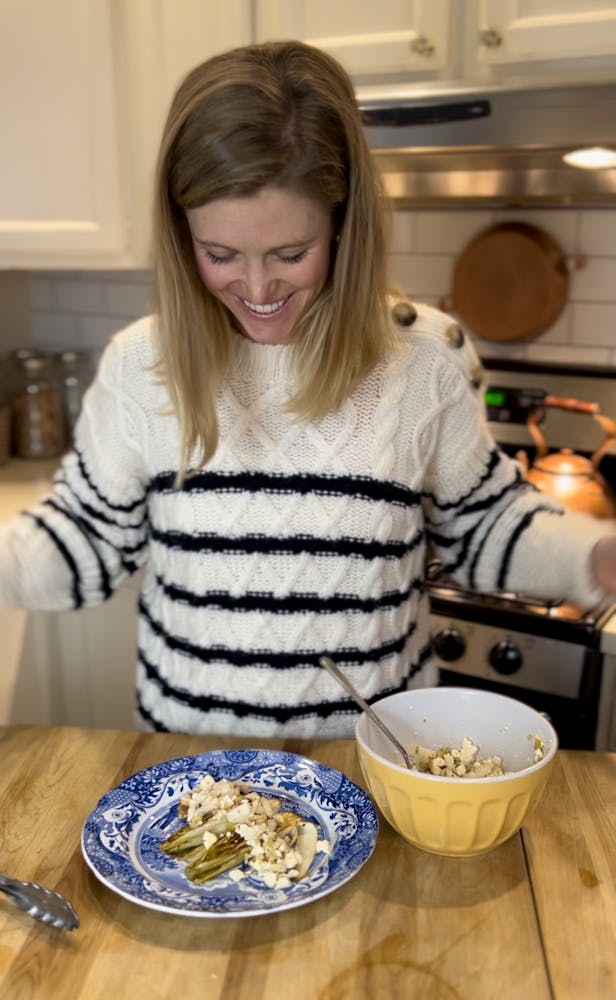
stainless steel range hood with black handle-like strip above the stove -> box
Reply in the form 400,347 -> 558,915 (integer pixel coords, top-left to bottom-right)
357,83 -> 616,207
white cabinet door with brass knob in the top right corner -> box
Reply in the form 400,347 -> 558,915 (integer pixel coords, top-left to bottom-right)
475,0 -> 616,67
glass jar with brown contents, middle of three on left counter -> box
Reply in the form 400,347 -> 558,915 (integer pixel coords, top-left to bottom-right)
13,356 -> 66,458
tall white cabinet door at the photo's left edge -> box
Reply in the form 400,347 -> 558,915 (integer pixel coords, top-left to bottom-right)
0,0 -> 124,267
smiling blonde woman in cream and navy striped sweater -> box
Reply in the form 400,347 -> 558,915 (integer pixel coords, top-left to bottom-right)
0,43 -> 616,737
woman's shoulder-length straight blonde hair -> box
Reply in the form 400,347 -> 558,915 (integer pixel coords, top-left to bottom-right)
153,42 -> 393,479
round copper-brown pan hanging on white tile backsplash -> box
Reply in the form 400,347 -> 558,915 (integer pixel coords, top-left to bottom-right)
452,222 -> 569,342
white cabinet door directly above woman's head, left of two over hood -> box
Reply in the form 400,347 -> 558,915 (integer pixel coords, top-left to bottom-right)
255,0 -> 451,82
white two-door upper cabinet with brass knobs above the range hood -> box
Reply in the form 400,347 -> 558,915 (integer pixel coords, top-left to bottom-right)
255,0 -> 616,85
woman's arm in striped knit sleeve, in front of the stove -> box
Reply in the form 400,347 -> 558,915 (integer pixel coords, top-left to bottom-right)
422,334 -> 616,607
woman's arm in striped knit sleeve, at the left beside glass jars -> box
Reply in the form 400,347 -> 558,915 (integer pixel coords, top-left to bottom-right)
0,328 -> 148,610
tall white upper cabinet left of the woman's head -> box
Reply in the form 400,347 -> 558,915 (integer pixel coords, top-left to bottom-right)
0,0 -> 252,269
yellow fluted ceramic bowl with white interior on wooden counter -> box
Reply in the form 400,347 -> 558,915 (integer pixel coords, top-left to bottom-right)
355,687 -> 558,857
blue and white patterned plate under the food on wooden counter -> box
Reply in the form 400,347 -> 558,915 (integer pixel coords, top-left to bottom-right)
81,750 -> 378,917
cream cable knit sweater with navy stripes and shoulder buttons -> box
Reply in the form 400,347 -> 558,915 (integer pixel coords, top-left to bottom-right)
0,307 -> 605,737
